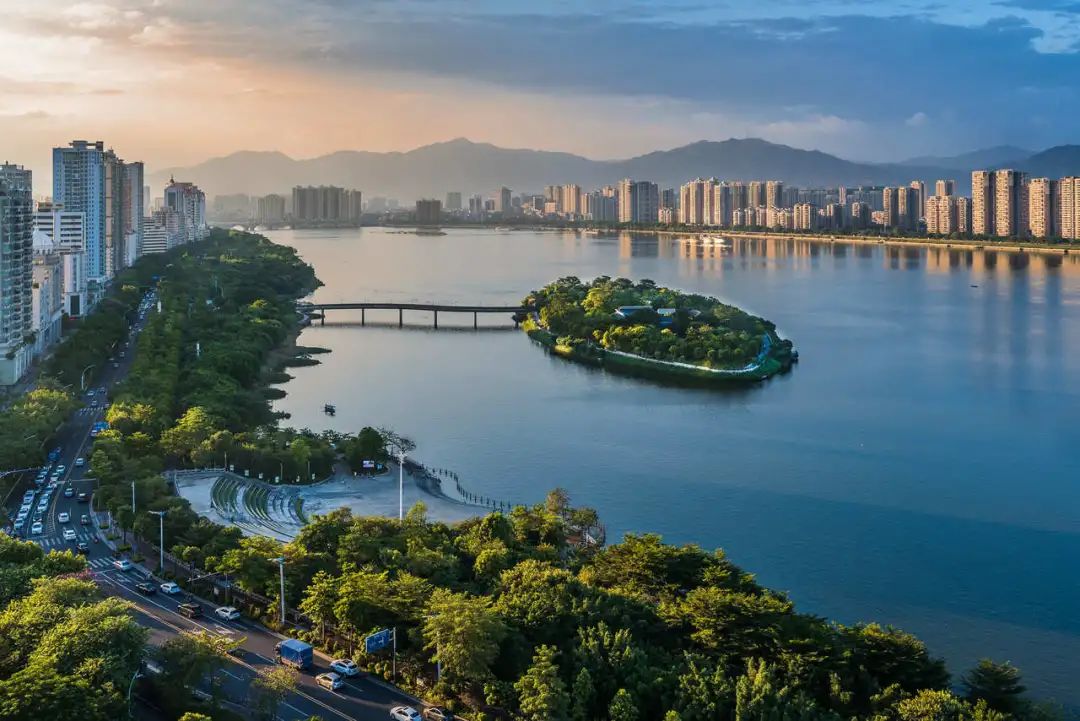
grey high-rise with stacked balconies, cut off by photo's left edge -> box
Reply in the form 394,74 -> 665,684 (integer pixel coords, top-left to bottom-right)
0,163 -> 33,385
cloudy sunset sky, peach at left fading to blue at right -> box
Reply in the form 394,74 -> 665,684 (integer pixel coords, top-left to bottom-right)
0,0 -> 1080,189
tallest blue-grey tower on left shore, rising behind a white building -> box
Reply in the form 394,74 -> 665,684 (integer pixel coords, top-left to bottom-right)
53,140 -> 106,282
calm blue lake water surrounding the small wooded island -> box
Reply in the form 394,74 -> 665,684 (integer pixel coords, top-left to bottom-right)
270,229 -> 1080,704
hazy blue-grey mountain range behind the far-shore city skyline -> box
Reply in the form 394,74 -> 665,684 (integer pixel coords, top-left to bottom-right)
149,138 -> 1080,202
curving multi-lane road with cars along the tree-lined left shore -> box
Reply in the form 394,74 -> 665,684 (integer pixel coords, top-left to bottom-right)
4,289 -> 420,721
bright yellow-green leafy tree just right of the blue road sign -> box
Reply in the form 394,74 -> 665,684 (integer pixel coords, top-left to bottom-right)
423,588 -> 507,682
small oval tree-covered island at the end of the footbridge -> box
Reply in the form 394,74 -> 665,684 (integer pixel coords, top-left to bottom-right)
522,275 -> 798,383
